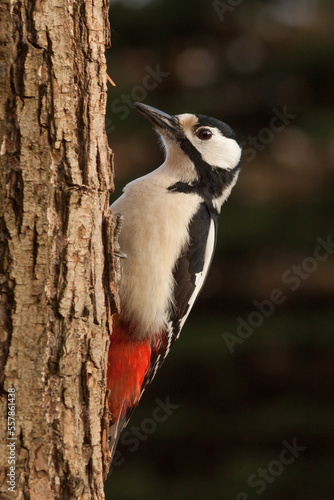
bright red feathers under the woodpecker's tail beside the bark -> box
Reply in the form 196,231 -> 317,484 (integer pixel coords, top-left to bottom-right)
107,318 -> 151,456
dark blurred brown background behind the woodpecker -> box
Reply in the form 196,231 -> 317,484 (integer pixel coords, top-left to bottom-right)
106,0 -> 334,500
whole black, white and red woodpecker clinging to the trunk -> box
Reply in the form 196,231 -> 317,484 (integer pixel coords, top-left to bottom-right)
107,103 -> 241,456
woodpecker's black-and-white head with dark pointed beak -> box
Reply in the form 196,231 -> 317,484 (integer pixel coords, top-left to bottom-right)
135,103 -> 241,210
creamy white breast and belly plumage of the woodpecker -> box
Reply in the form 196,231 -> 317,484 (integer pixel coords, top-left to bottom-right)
111,167 -> 201,338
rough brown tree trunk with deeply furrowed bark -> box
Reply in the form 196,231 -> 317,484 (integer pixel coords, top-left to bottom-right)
0,0 -> 117,500
